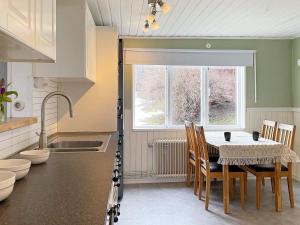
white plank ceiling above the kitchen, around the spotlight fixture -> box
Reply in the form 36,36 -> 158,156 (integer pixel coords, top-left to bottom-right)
88,0 -> 300,38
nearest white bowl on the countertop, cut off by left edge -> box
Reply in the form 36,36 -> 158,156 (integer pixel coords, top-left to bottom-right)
0,171 -> 16,201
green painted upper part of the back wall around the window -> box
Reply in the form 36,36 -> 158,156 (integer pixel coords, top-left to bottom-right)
124,39 -> 292,108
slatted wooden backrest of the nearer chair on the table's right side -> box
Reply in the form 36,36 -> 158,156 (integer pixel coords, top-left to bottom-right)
275,123 -> 296,150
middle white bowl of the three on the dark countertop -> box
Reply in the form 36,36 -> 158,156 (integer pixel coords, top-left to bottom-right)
0,159 -> 31,180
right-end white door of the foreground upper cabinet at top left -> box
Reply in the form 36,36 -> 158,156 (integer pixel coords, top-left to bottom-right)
36,0 -> 56,59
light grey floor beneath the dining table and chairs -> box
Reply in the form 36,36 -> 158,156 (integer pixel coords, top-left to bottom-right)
118,179 -> 300,225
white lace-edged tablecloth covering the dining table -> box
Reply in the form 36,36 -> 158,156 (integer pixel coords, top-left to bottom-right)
205,132 -> 299,165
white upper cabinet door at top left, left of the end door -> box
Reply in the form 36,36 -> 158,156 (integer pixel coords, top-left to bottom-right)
7,0 -> 35,47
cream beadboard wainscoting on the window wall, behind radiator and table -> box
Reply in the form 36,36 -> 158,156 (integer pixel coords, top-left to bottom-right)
124,108 -> 300,183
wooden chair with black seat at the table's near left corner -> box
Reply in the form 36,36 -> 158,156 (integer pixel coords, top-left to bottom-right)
195,126 -> 247,210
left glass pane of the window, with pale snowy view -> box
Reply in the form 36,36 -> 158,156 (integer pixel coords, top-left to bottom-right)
134,65 -> 166,127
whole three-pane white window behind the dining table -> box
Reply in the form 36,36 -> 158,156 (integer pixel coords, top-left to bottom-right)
133,65 -> 245,129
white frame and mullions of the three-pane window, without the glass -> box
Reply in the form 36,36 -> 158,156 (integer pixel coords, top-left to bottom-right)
131,65 -> 246,131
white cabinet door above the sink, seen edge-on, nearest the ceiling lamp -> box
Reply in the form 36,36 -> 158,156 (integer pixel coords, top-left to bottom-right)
86,6 -> 97,81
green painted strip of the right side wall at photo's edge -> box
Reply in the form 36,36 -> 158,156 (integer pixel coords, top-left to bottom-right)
292,38 -> 300,107
